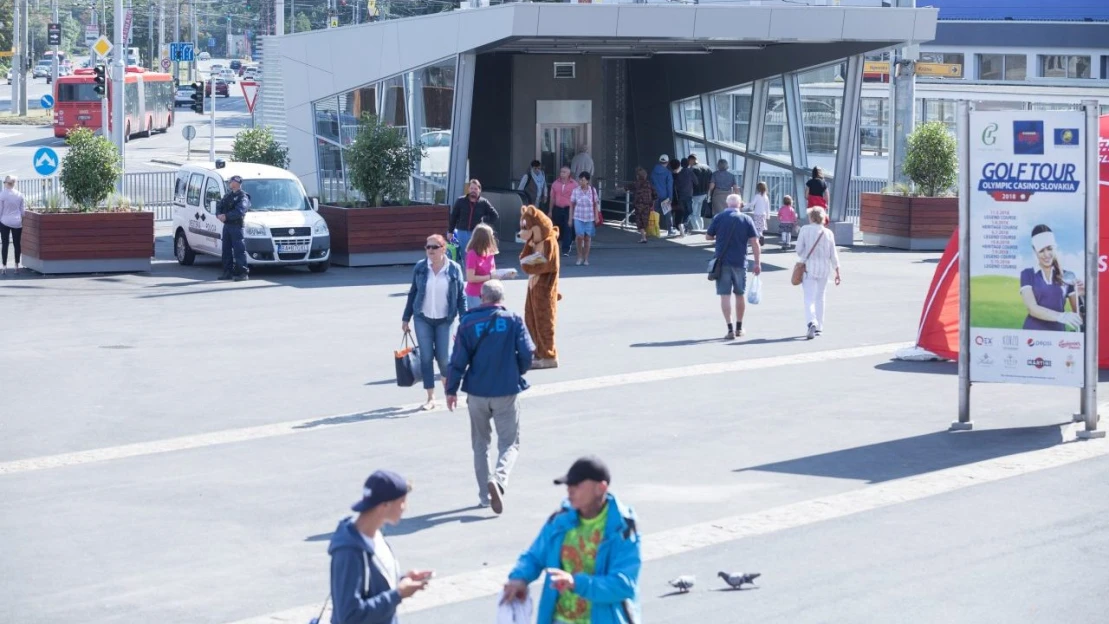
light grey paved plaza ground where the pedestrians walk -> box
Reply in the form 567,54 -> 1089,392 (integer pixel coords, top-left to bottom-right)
0,233 -> 1109,624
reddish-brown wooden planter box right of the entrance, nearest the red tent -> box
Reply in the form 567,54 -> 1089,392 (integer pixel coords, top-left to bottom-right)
858,193 -> 959,252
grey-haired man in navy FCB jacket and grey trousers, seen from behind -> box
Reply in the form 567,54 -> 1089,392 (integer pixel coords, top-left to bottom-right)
447,279 -> 536,514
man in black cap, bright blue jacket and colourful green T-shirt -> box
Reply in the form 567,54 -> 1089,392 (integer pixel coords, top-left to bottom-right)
502,457 -> 642,624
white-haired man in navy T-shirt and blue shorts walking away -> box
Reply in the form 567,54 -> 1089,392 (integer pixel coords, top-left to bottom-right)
704,193 -> 762,340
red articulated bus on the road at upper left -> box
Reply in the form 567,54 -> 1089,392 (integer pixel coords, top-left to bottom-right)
54,68 -> 176,140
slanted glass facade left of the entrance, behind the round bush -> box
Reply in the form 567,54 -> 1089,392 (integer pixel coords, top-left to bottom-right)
313,57 -> 457,204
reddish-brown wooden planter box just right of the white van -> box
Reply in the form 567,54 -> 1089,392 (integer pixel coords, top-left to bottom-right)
319,205 -> 450,266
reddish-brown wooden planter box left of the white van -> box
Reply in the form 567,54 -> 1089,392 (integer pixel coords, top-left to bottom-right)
22,211 -> 154,274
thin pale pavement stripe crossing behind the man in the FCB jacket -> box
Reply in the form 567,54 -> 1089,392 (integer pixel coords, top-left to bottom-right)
0,342 -> 908,477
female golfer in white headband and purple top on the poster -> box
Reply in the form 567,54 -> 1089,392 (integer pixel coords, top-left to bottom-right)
1020,224 -> 1086,331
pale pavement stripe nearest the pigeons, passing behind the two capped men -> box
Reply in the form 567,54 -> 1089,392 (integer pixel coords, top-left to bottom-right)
222,427 -> 1109,624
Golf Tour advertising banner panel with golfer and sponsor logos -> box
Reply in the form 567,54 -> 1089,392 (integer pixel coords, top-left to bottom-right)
966,111 -> 1097,387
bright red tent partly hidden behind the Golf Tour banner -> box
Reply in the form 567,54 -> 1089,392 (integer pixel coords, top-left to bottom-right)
913,115 -> 1109,368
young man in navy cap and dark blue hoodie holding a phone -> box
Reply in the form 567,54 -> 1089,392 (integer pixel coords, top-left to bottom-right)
327,470 -> 433,624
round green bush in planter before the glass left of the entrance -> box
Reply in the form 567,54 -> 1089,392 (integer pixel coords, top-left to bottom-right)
346,113 -> 425,206
